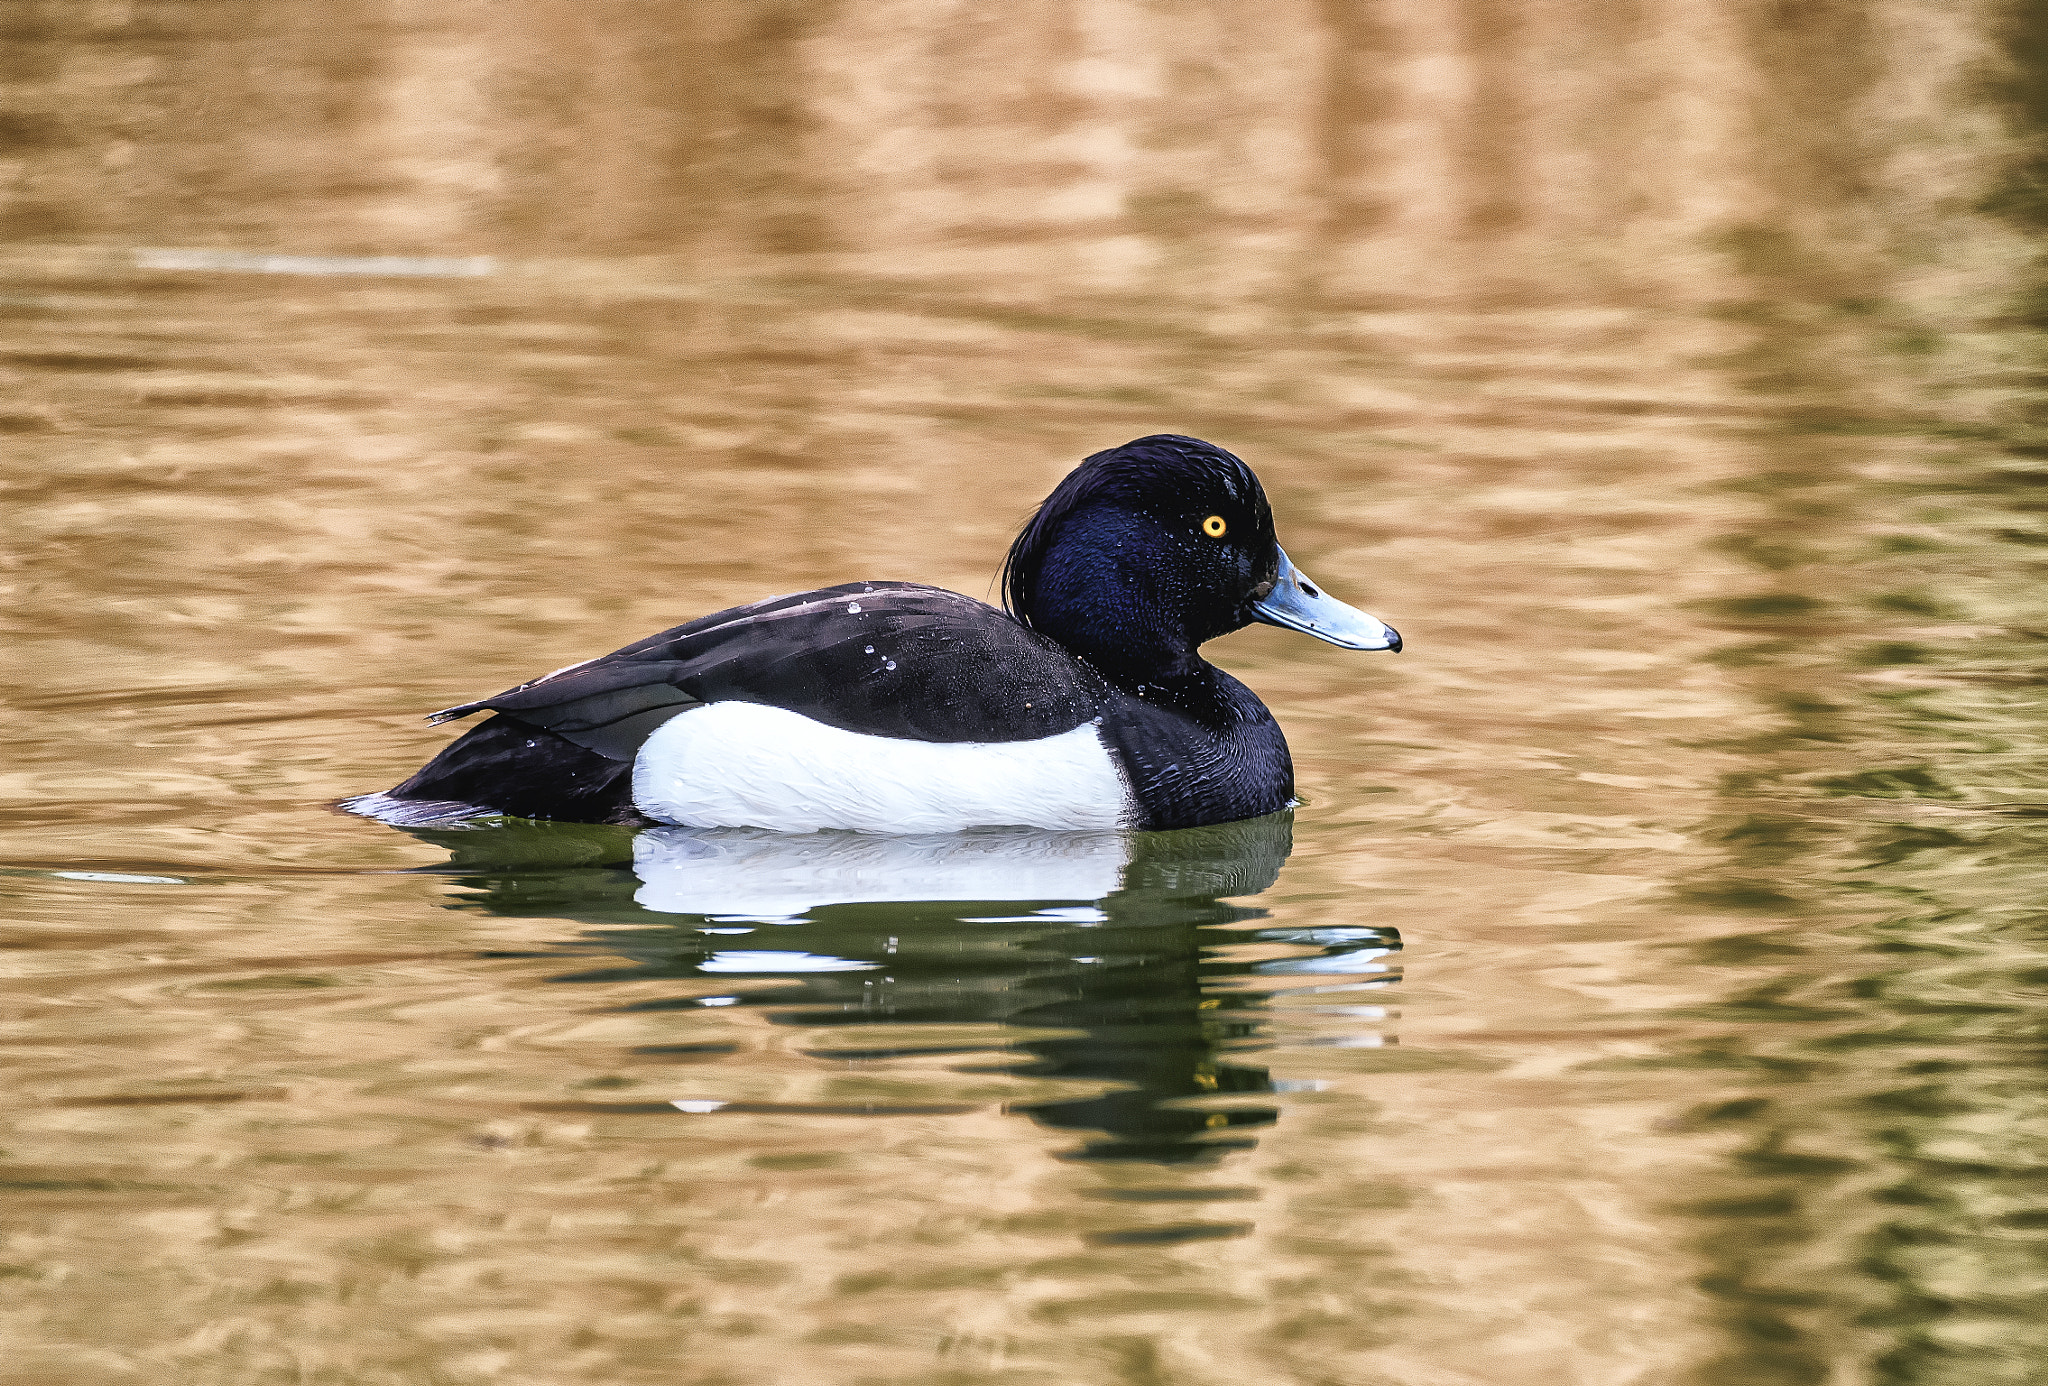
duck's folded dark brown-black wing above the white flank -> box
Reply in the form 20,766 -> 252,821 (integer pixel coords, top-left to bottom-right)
434,583 -> 1108,762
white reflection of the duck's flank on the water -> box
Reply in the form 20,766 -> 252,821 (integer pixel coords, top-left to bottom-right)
633,814 -> 1130,913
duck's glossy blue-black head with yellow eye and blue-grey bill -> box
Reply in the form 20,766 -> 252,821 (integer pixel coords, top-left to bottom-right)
1004,434 -> 1401,686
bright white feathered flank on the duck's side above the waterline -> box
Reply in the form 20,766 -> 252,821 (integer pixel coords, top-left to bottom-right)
633,702 -> 1130,833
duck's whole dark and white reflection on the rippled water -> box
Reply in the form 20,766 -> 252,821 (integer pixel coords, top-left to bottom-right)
414,813 -> 1401,1165
